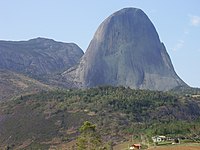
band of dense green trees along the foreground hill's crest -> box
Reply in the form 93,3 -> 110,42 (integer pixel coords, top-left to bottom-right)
15,86 -> 178,121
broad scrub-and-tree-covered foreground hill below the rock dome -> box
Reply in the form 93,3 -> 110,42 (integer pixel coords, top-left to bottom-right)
0,86 -> 200,148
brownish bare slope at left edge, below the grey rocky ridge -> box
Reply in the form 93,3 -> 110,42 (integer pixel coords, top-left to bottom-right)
0,70 -> 53,101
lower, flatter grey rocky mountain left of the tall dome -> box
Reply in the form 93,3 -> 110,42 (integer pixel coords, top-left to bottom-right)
0,38 -> 83,77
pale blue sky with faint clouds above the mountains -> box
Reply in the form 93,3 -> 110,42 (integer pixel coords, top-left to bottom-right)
0,0 -> 200,87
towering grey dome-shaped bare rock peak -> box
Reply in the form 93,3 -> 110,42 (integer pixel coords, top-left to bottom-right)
63,8 -> 186,91
